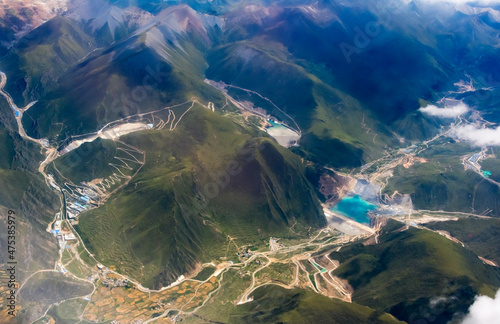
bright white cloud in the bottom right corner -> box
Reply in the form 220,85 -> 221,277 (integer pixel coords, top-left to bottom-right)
462,289 -> 500,324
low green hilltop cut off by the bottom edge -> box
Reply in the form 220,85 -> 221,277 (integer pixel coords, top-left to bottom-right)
231,285 -> 402,324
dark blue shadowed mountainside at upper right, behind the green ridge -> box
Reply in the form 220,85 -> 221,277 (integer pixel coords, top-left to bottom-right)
221,2 -> 454,124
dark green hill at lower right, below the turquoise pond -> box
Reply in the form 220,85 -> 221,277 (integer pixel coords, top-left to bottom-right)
331,220 -> 500,323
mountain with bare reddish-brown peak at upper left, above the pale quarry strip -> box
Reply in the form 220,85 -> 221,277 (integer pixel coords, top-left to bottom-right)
23,24 -> 225,141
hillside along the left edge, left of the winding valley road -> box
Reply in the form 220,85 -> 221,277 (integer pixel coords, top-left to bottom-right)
0,92 -> 92,323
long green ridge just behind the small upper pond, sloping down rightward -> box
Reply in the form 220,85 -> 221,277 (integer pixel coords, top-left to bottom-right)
206,38 -> 395,167
